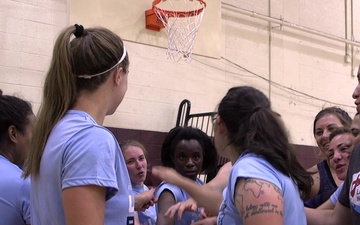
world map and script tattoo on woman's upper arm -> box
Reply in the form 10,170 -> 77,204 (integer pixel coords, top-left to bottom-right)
235,178 -> 283,219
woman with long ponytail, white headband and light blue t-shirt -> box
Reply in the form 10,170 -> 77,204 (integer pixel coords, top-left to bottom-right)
25,24 -> 134,225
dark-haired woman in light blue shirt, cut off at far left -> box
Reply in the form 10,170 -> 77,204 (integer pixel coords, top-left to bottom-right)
0,90 -> 35,225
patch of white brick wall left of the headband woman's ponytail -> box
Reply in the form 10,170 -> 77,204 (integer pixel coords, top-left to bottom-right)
0,0 -> 69,111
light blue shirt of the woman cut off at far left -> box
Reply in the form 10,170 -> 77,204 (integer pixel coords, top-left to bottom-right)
0,155 -> 30,225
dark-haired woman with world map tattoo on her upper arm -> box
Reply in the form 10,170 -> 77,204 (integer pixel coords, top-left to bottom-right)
214,86 -> 312,225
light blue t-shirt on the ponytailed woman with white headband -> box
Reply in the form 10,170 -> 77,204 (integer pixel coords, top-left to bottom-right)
31,110 -> 134,225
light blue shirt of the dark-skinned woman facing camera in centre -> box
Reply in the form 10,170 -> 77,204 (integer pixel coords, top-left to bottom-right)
155,178 -> 204,225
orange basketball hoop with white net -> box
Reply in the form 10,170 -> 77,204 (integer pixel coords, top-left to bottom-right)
146,0 -> 206,61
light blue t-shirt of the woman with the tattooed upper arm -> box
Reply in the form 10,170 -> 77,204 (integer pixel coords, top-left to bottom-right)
217,153 -> 306,225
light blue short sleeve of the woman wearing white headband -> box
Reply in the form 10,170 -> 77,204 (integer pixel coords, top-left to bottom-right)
62,127 -> 118,199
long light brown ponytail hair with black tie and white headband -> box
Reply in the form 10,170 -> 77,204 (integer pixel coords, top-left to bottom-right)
24,26 -> 129,177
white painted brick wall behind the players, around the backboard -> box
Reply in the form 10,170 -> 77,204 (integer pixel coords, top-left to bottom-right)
0,0 -> 360,145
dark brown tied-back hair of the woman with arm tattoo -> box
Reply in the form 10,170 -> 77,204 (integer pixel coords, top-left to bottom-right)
218,86 -> 313,199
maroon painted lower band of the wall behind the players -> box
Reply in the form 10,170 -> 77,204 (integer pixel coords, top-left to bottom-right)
107,127 -> 323,186
